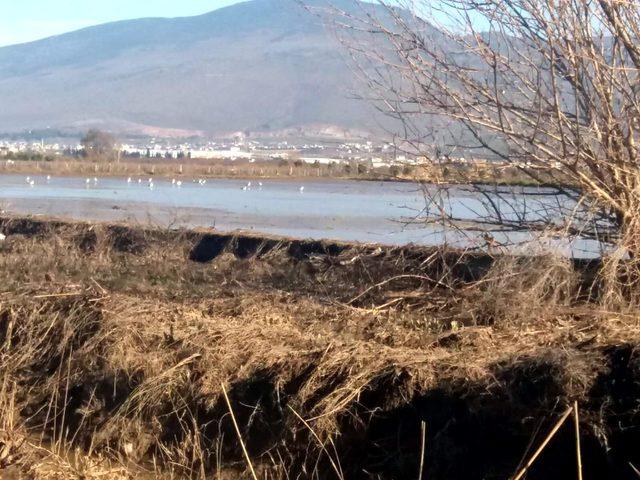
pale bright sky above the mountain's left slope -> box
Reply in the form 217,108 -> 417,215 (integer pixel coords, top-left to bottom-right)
0,0 -> 245,46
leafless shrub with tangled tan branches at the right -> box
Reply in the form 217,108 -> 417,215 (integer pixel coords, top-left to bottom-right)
316,0 -> 640,294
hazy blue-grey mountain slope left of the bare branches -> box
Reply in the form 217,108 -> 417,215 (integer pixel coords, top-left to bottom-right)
0,0 -> 390,136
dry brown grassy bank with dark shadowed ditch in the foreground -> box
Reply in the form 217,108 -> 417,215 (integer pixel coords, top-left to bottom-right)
0,219 -> 640,480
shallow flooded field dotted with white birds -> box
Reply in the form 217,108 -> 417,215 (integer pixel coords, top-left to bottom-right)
0,175 -> 594,256
